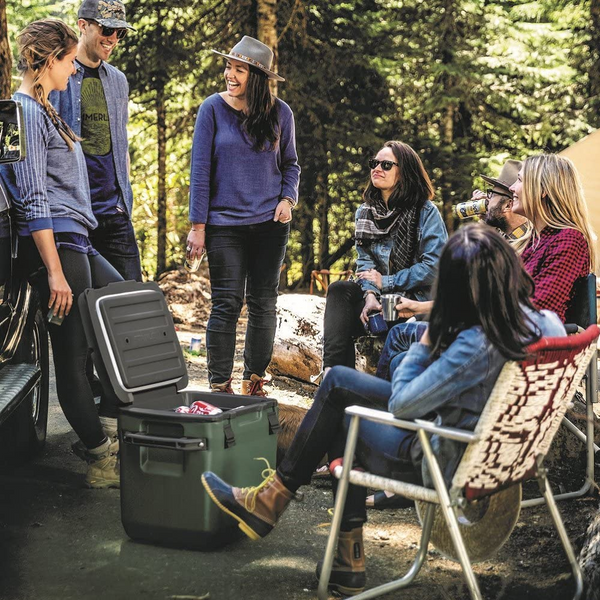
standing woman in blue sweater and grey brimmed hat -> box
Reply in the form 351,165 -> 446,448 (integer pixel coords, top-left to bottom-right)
187,36 -> 300,395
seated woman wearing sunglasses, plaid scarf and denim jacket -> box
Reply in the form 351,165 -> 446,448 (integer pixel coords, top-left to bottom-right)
323,141 -> 448,373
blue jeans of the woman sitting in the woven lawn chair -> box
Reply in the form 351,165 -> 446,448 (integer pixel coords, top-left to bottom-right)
277,366 -> 419,528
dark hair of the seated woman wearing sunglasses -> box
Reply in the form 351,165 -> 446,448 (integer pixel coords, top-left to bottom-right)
363,140 -> 434,209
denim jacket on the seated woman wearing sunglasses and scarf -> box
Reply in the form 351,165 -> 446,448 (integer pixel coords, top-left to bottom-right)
356,200 -> 448,301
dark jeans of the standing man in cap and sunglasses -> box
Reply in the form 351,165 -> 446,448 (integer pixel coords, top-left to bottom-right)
89,211 -> 142,281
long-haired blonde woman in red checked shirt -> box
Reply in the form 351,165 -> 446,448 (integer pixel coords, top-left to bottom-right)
510,154 -> 596,322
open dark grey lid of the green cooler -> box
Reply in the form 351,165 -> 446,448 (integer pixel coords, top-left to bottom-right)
80,281 -> 188,402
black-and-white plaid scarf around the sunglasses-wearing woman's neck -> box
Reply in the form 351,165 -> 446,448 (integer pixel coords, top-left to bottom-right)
354,198 -> 423,273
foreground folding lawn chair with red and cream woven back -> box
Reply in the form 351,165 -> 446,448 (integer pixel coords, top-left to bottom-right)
318,325 -> 600,600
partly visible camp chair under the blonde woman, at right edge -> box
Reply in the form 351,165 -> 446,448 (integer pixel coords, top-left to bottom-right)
521,273 -> 599,508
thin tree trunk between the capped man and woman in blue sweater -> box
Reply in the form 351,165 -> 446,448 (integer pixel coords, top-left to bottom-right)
156,86 -> 167,277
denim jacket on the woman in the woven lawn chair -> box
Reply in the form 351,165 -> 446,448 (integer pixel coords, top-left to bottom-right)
388,310 -> 566,485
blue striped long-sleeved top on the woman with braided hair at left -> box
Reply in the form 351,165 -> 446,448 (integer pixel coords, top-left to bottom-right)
0,92 -> 98,235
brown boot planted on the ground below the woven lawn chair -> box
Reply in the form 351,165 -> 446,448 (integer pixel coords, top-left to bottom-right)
316,527 -> 367,596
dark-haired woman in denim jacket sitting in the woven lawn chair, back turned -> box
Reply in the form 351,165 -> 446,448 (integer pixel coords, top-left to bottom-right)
202,225 -> 565,595
